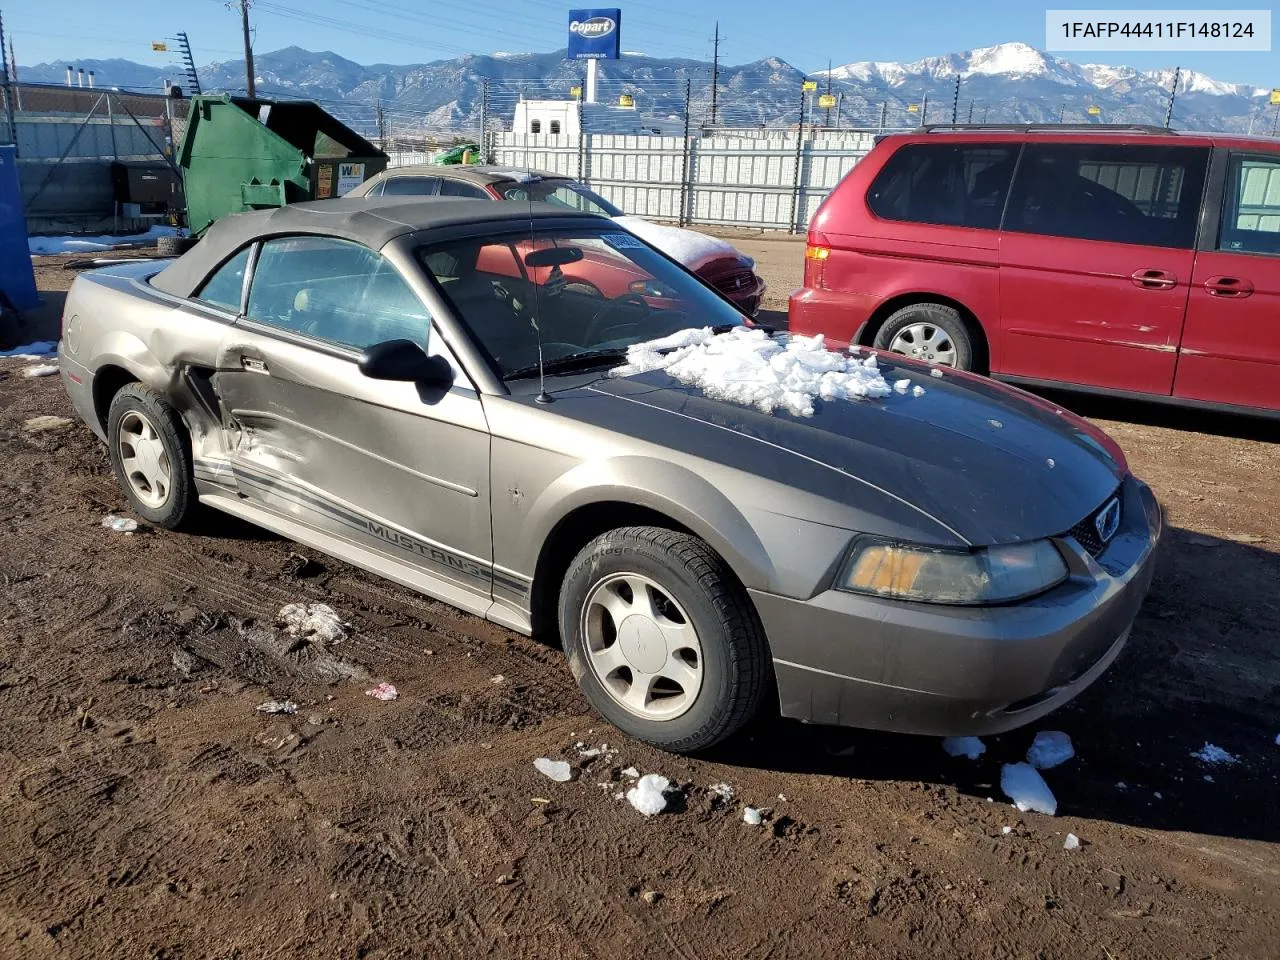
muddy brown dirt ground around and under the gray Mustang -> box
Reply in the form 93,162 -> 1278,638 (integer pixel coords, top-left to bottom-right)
0,252 -> 1280,960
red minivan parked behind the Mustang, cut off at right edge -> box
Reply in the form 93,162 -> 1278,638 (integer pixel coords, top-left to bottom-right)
790,125 -> 1280,415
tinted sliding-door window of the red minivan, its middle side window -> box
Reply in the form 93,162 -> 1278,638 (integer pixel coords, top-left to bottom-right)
1005,143 -> 1208,248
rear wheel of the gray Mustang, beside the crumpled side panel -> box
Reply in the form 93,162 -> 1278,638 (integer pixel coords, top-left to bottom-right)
106,383 -> 197,530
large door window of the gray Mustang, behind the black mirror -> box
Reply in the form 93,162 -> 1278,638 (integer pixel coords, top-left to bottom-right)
241,237 -> 430,349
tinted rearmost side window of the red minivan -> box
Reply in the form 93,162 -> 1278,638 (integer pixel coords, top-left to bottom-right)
867,143 -> 1018,230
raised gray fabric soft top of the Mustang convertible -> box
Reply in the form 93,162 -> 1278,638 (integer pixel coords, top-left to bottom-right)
151,197 -> 604,297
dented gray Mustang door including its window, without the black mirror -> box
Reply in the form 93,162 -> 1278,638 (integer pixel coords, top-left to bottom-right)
214,237 -> 493,599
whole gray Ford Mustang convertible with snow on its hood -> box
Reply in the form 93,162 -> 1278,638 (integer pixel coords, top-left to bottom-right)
59,198 -> 1161,751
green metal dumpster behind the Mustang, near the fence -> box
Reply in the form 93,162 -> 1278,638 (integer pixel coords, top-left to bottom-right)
178,93 -> 387,234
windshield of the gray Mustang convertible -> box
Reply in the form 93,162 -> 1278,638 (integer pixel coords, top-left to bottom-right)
417,224 -> 746,379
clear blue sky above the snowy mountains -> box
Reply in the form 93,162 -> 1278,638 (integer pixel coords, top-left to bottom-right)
10,0 -> 1280,87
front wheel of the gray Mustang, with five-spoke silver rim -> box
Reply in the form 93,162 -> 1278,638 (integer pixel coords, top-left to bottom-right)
559,526 -> 769,753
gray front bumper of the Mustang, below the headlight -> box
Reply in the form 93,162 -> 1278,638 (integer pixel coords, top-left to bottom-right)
751,477 -> 1164,736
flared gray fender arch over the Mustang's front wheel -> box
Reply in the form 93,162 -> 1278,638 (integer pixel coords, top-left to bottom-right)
517,456 -> 777,590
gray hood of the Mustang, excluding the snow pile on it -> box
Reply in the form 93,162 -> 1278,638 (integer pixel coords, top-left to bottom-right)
562,360 -> 1126,544
